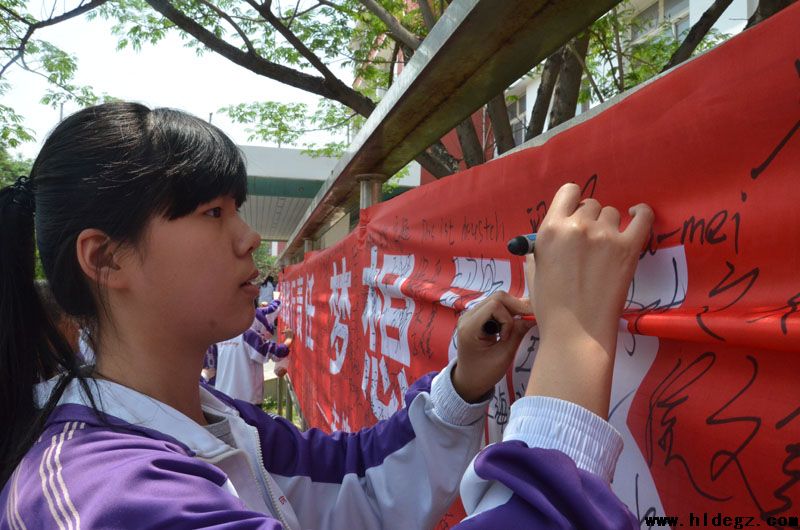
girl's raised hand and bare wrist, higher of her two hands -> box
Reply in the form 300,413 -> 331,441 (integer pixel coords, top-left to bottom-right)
526,184 -> 653,418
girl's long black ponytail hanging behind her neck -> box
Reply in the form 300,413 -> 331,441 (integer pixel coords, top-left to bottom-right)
0,177 -> 76,487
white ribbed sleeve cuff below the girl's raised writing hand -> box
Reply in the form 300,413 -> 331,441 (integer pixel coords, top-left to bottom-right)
503,396 -> 623,482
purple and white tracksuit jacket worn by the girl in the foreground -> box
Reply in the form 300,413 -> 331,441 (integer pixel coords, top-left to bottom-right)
0,358 -> 638,530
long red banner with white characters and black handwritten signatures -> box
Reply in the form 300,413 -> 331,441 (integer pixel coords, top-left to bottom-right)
281,4 -> 800,525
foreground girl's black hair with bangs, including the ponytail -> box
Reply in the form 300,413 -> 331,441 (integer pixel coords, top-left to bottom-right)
0,102 -> 247,486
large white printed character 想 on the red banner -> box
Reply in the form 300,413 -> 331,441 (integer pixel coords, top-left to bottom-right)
361,246 -> 415,419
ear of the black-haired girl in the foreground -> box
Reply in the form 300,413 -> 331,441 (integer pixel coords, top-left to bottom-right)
75,228 -> 127,289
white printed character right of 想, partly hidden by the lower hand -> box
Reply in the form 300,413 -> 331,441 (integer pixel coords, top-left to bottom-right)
439,257 -> 511,360
